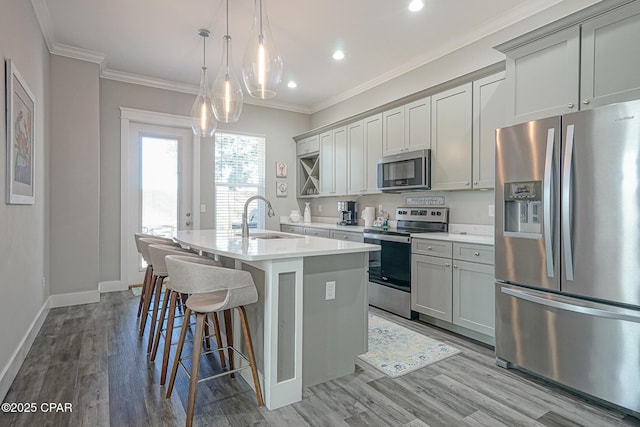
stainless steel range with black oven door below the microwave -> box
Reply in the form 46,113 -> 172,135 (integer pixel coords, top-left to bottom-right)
364,206 -> 449,319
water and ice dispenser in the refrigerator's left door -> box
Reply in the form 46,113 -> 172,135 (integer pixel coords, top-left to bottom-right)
504,181 -> 542,239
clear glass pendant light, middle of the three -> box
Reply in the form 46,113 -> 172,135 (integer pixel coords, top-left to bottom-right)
211,0 -> 244,123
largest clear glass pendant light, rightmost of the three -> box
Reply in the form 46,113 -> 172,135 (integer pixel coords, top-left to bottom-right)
242,0 -> 282,99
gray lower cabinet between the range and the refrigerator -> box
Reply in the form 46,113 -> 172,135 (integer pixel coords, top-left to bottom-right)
411,239 -> 495,337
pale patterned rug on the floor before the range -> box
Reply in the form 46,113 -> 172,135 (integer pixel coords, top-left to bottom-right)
358,313 -> 460,378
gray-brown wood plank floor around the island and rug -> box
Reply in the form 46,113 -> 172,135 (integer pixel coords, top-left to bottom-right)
0,291 -> 640,427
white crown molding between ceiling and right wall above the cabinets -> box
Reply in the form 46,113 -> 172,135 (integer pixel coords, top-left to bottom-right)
311,0 -> 562,114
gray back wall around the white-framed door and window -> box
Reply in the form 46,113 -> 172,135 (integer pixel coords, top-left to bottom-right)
99,79 -> 310,282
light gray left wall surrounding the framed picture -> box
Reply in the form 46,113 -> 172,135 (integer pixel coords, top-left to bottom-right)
0,0 -> 49,400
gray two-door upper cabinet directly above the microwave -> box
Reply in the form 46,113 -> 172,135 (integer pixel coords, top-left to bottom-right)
382,97 -> 431,156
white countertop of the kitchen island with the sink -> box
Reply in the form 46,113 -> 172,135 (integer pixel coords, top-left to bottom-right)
175,227 -> 380,261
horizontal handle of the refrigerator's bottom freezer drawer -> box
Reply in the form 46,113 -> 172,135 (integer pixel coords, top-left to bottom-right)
500,287 -> 640,323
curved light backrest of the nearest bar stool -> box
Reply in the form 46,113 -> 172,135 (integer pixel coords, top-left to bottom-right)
165,255 -> 258,310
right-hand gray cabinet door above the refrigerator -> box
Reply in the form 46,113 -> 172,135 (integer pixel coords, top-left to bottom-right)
580,3 -> 640,109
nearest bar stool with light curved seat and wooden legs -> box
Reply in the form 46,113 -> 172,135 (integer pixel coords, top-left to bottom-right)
165,255 -> 263,427
